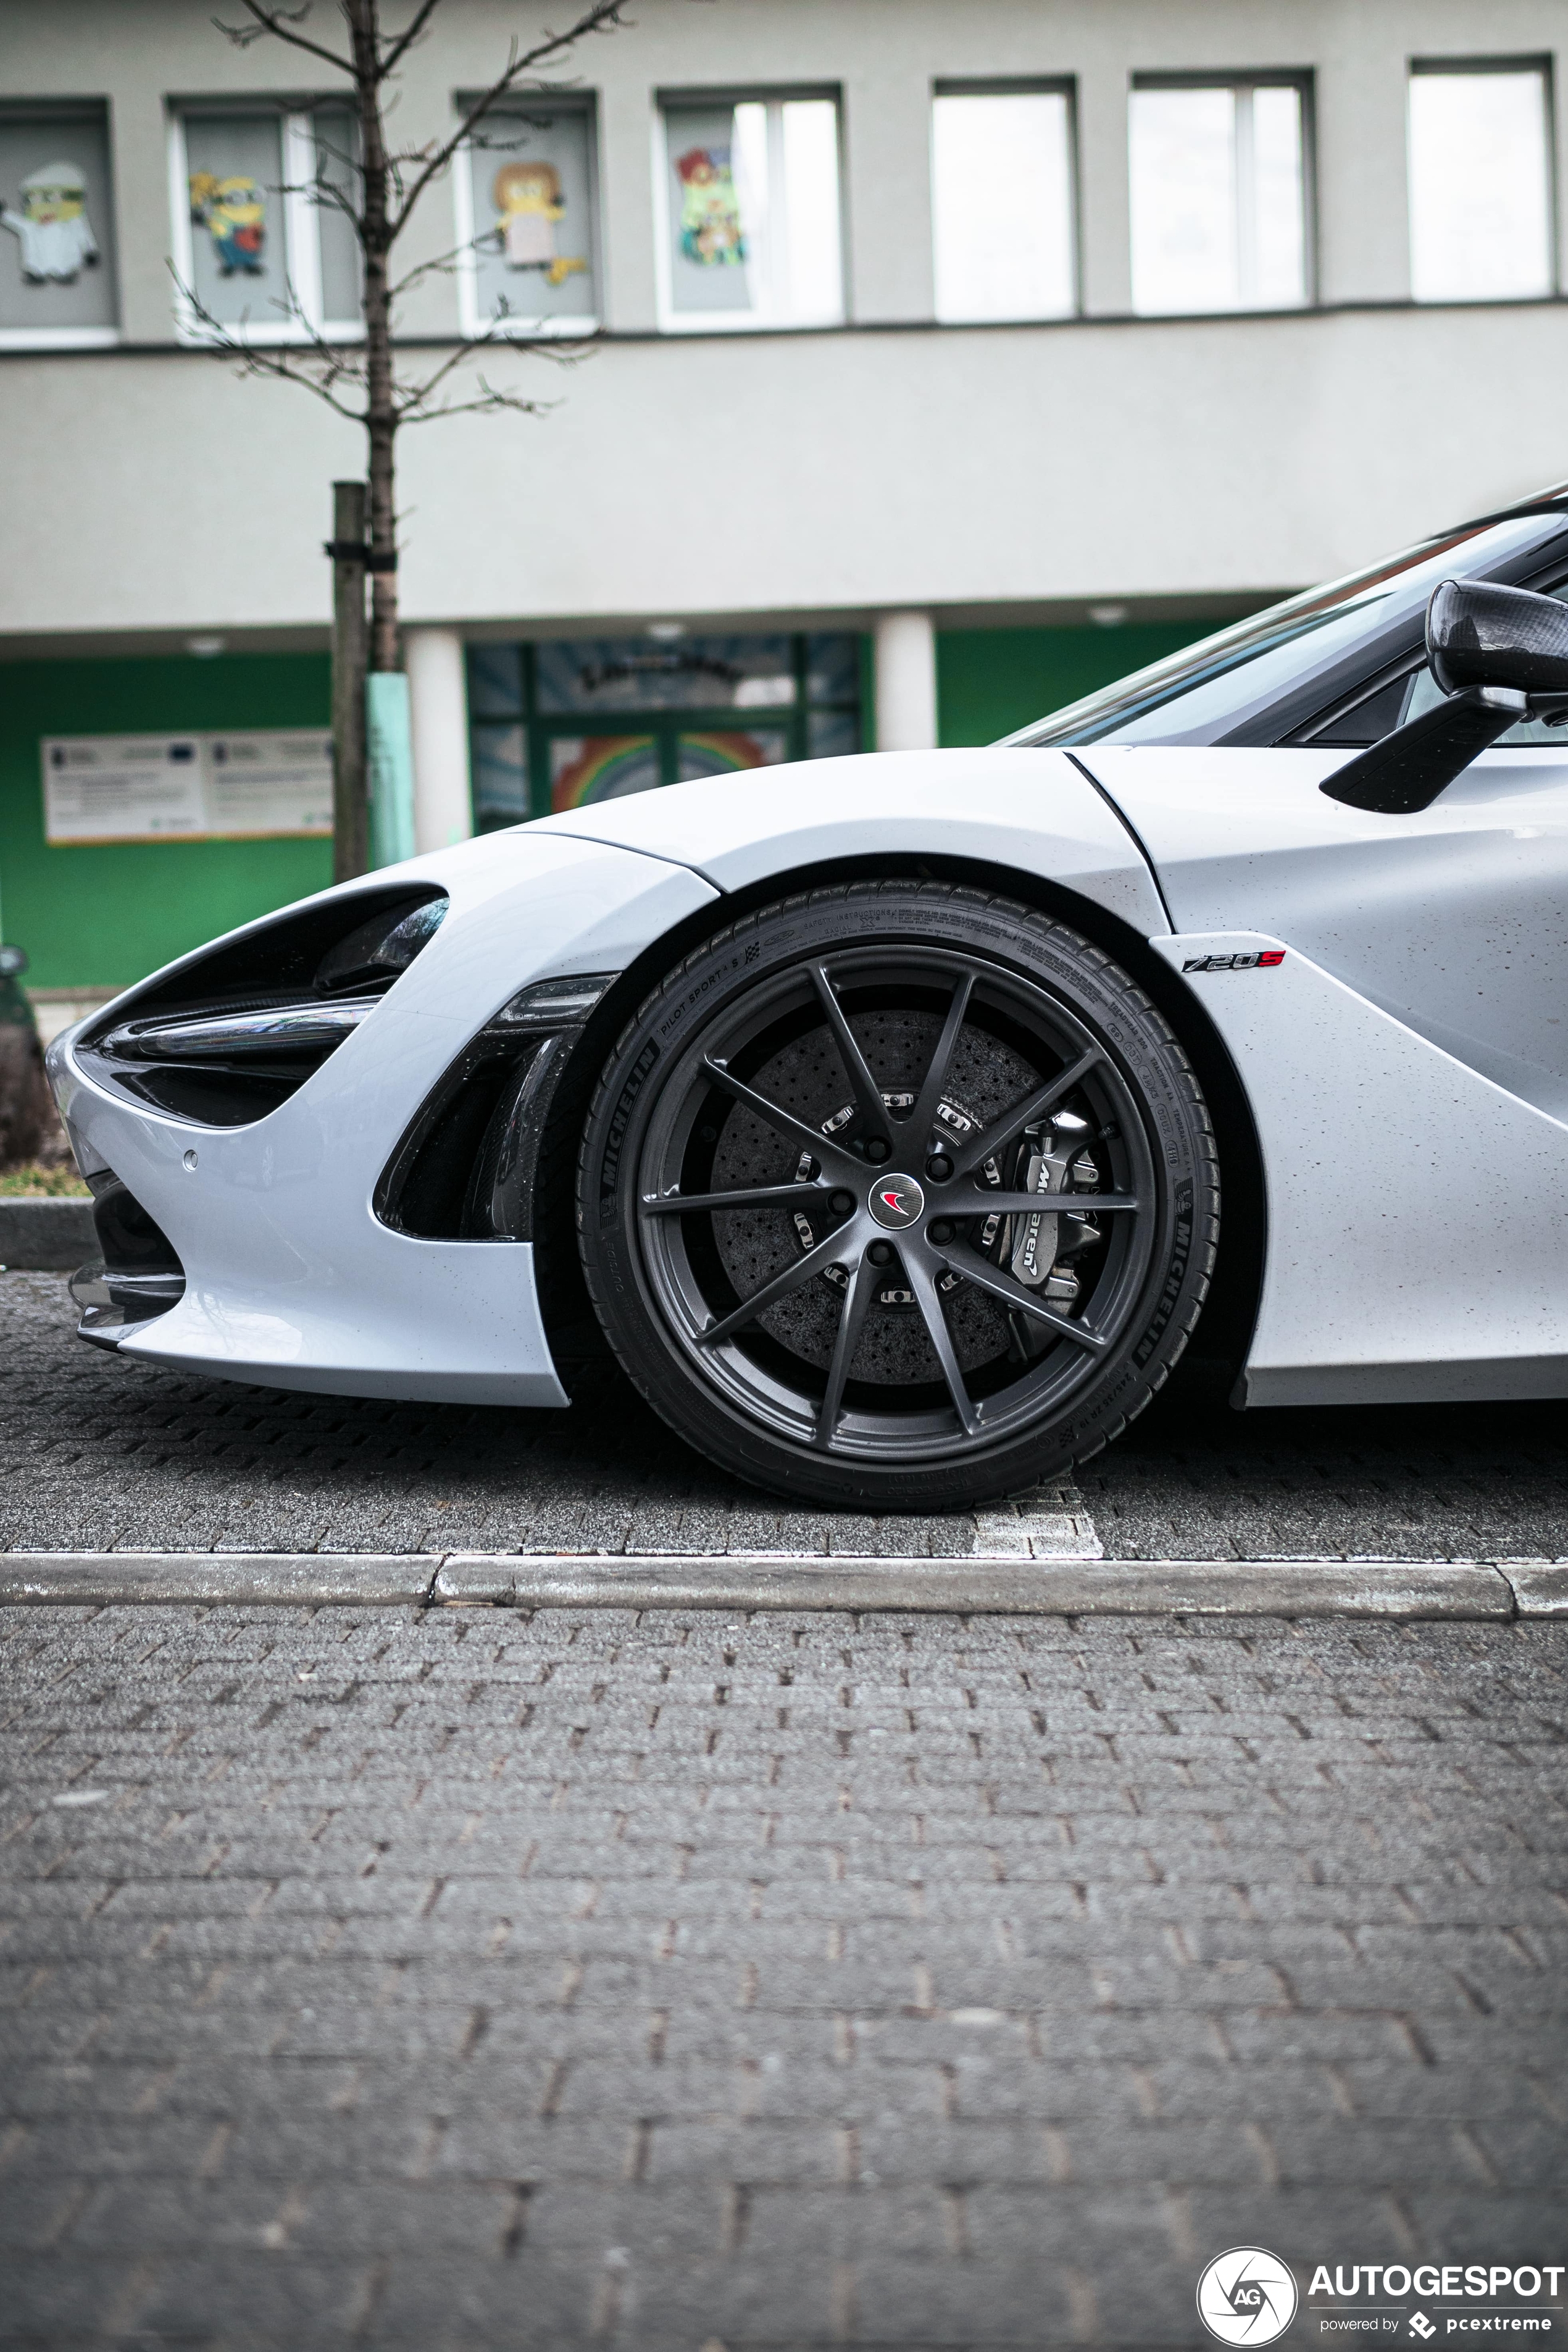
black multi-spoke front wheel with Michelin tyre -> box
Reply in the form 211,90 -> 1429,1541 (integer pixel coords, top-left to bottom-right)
581,882 -> 1218,1508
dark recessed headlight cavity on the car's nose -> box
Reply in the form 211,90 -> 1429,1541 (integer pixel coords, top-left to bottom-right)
78,889 -> 447,1127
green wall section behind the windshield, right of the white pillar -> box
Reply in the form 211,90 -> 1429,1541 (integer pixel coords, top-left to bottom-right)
936,621 -> 1222,743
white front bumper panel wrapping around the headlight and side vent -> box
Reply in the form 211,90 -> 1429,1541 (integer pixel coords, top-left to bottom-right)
49,831 -> 715,1404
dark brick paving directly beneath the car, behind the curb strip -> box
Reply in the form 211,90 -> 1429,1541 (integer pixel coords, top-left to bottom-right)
0,1274 -> 1568,1559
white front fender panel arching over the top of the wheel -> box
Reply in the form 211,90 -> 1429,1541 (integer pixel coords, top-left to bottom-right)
529,745 -> 1170,939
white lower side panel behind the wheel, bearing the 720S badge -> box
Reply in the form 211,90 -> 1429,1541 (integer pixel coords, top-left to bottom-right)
1154,931 -> 1568,1404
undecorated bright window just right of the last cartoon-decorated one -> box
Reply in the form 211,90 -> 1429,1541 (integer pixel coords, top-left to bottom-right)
931,90 -> 1077,322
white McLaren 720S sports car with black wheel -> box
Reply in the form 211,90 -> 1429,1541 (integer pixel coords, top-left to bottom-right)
49,487 -> 1568,1510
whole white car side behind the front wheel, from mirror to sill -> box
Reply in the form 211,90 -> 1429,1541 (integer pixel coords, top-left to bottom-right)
1082,745 -> 1568,1404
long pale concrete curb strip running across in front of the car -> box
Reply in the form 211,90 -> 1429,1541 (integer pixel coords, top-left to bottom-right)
0,1550 -> 1568,1620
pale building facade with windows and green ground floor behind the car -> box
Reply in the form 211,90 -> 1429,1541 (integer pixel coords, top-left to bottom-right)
0,0 -> 1568,1004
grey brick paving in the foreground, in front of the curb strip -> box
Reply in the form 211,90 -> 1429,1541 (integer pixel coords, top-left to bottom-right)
0,1609 -> 1568,2352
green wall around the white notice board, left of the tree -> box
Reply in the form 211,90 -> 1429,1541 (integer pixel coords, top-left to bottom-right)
0,654 -> 332,988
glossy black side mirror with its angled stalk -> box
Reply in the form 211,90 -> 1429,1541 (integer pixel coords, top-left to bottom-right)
1319,581 -> 1568,816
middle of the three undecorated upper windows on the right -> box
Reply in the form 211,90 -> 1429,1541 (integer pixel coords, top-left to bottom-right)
1128,80 -> 1307,313
